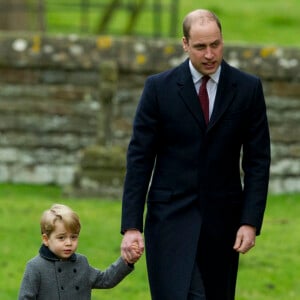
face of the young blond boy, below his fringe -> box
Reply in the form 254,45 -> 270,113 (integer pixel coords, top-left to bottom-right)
42,221 -> 79,259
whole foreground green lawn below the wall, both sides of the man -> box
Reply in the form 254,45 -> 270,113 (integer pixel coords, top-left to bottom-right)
0,184 -> 300,300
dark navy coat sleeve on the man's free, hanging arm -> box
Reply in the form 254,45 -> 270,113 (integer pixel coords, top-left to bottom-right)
241,79 -> 271,235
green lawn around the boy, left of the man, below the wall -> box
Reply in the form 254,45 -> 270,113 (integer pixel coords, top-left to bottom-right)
0,184 -> 149,300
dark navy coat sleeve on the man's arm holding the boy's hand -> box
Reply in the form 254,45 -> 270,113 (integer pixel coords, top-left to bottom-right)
121,76 -> 159,232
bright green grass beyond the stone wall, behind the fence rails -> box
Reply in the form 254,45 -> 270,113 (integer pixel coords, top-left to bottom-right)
41,0 -> 300,46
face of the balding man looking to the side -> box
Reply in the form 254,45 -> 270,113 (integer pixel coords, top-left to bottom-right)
182,21 -> 223,75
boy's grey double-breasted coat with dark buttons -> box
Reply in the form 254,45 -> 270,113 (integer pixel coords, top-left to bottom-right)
19,246 -> 133,300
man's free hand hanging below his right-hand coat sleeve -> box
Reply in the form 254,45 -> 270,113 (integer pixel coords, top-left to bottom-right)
233,225 -> 256,254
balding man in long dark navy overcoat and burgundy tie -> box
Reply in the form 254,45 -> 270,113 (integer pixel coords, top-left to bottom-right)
121,10 -> 270,300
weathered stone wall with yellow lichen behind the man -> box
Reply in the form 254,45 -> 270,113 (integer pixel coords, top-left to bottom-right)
0,33 -> 300,196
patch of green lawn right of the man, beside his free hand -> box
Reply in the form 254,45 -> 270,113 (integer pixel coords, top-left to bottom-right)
237,195 -> 300,300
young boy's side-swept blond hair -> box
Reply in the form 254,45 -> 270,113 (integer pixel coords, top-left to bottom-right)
40,204 -> 81,237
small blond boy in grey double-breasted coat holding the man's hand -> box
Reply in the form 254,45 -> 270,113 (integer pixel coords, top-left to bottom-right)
19,204 -> 142,300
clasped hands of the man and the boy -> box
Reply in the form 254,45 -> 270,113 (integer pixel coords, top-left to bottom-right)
121,229 -> 144,264
